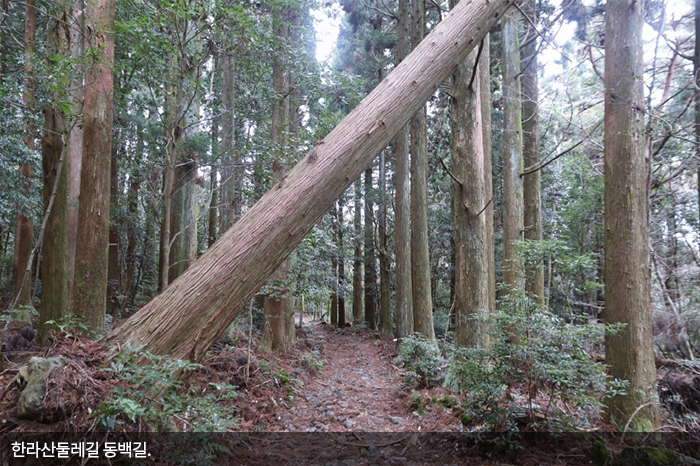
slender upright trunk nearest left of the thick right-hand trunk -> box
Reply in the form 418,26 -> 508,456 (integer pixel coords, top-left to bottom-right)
520,0 -> 544,304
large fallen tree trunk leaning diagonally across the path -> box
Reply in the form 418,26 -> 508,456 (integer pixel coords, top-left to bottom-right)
107,0 -> 513,361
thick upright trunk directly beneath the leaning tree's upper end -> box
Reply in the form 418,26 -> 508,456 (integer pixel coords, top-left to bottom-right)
450,39 -> 489,348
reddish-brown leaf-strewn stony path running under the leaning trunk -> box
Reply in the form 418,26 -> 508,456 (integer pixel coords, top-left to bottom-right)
270,322 -> 461,432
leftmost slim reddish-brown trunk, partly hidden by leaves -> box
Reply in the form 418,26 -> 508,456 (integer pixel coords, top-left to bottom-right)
12,0 -> 36,306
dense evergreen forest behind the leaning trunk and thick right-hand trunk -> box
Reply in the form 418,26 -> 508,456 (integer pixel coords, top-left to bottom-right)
0,0 -> 700,436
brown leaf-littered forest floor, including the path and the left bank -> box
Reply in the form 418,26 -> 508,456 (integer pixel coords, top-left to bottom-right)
0,314 -> 696,466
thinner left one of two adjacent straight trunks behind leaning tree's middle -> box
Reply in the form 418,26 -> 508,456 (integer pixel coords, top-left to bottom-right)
394,0 -> 414,338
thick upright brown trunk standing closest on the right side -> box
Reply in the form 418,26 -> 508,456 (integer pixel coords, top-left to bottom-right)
603,0 -> 659,432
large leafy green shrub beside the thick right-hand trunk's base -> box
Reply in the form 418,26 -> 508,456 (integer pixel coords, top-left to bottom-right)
446,290 -> 622,430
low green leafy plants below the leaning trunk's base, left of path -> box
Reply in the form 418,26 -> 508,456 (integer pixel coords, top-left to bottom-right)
95,347 -> 237,432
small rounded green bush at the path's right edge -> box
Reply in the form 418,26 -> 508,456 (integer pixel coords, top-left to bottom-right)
392,335 -> 446,388
